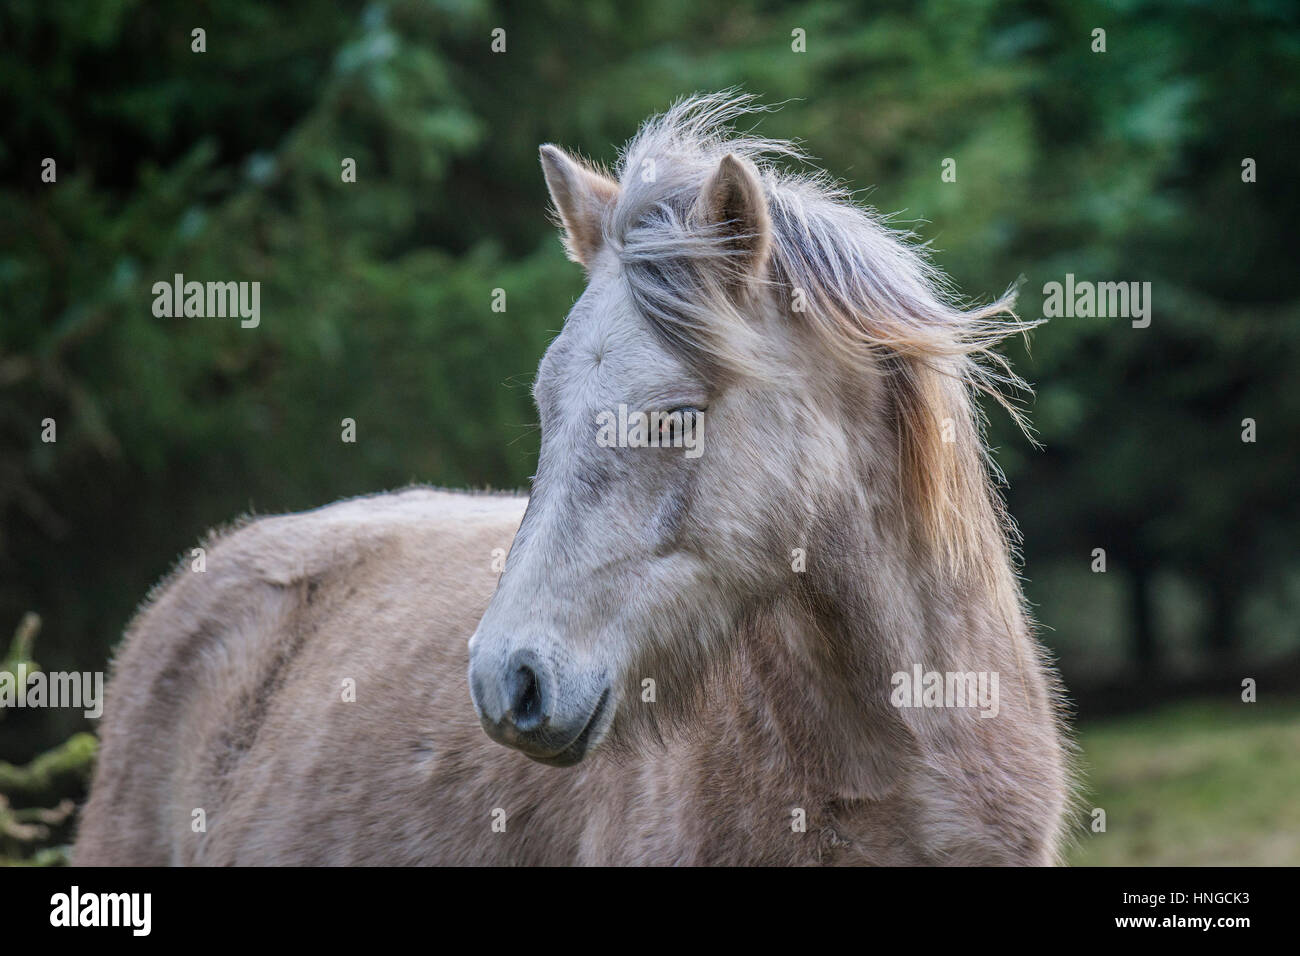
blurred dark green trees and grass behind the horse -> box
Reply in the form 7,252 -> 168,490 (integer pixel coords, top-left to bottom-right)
0,0 -> 1300,862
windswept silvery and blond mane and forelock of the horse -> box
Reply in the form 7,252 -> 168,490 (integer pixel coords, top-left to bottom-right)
590,91 -> 1036,580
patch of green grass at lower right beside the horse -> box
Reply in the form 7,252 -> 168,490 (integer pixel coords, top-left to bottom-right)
1069,701 -> 1300,866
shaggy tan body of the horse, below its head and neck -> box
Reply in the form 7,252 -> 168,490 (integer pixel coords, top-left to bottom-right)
74,489 -> 1053,866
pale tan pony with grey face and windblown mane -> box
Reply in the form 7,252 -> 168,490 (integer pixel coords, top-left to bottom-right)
73,91 -> 1073,865
